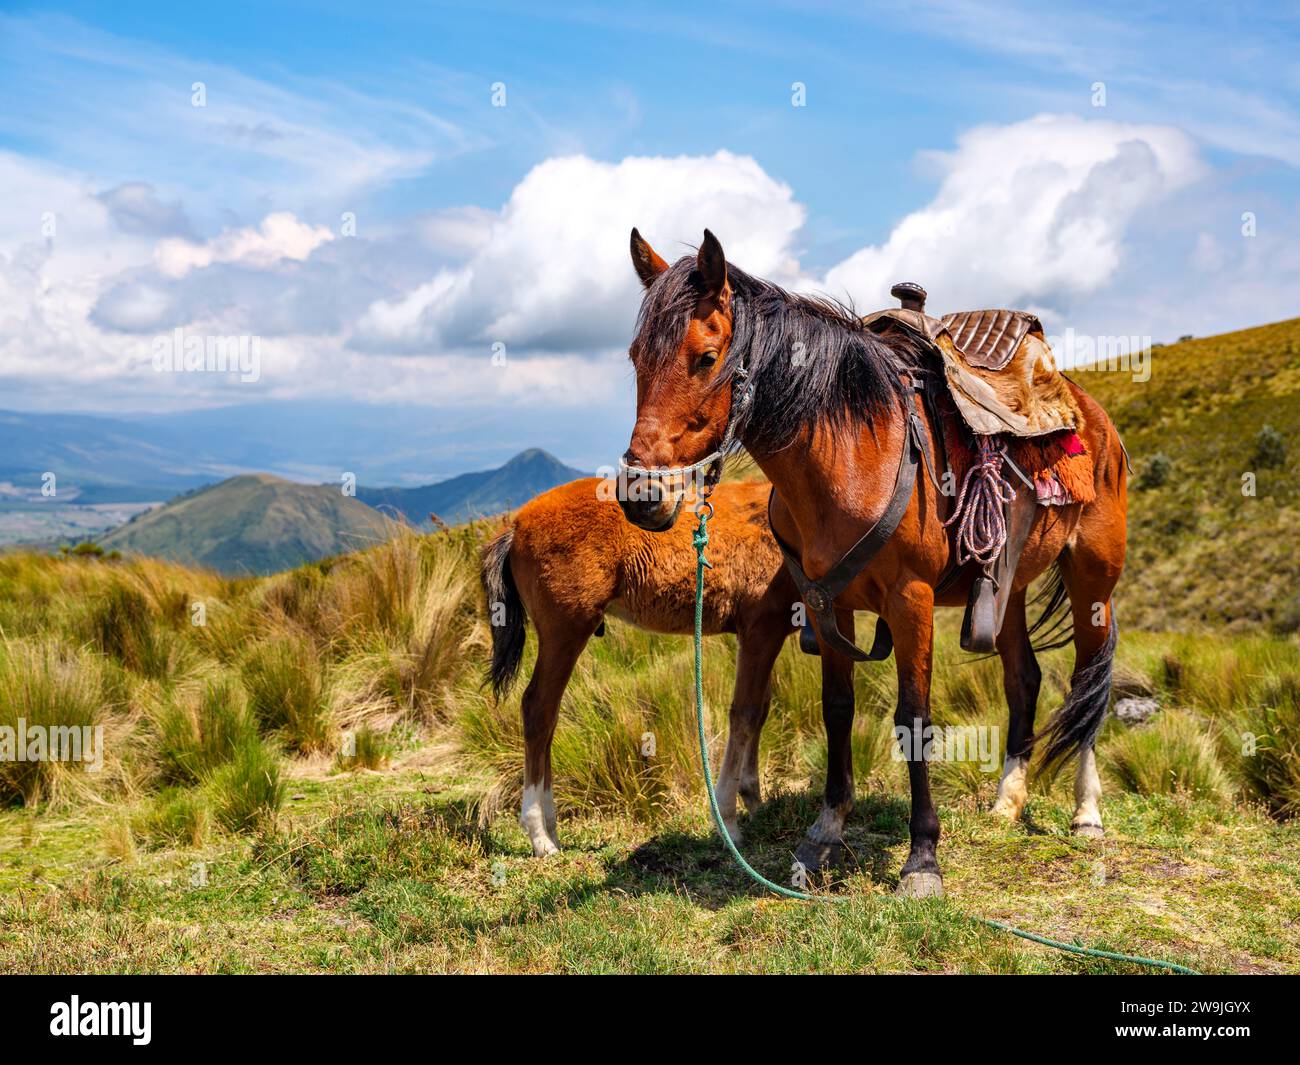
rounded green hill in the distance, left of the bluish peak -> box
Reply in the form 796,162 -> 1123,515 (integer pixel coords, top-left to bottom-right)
99,473 -> 390,573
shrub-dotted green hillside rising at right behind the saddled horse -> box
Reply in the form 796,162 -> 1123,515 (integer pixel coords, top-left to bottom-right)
1071,319 -> 1300,633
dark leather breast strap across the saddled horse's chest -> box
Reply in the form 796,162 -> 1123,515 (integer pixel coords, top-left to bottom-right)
767,377 -> 939,662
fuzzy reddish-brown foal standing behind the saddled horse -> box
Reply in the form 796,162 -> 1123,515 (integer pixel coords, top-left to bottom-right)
482,477 -> 798,857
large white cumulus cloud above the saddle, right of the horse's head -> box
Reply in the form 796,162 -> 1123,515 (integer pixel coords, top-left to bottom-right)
819,114 -> 1203,312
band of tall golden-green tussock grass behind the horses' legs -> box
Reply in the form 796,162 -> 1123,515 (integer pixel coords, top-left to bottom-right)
0,512 -> 1300,840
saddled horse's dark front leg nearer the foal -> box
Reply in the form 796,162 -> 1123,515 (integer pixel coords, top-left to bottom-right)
794,610 -> 854,873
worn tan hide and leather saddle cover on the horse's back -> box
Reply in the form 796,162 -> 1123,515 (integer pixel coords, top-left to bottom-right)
862,309 -> 1083,437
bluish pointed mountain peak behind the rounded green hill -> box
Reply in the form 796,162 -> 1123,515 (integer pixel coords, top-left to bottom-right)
356,447 -> 589,525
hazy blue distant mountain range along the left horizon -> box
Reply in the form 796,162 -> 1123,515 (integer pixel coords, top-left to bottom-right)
0,397 -> 618,507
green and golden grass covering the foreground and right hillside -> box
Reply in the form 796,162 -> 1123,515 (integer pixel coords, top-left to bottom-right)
0,343 -> 1300,973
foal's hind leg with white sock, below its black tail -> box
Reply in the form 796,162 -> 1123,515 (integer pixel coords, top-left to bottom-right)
519,623 -> 594,858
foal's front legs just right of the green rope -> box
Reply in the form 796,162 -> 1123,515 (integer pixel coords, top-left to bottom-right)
718,616 -> 787,843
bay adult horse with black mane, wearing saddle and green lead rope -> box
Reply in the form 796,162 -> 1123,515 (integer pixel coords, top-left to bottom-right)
623,230 -> 1127,896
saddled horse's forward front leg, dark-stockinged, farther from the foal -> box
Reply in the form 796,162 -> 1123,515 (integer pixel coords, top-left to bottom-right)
885,581 -> 944,899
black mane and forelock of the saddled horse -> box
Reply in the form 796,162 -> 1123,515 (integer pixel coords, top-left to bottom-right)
632,256 -> 915,454
